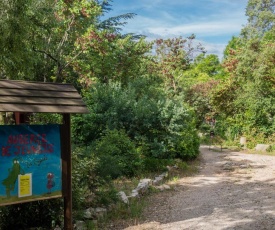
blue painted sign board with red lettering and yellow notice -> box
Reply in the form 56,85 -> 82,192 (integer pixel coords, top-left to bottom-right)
0,125 -> 62,205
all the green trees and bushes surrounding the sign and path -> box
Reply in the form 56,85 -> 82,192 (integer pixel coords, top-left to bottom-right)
0,0 -> 275,229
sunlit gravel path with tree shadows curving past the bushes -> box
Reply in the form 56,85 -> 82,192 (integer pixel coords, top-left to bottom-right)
123,146 -> 275,230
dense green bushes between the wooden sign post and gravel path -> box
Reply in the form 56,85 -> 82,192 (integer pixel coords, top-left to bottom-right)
72,77 -> 199,212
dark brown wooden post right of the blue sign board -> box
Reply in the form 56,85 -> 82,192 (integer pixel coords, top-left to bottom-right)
61,114 -> 73,230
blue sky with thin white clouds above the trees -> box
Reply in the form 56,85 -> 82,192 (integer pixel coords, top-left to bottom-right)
106,0 -> 248,58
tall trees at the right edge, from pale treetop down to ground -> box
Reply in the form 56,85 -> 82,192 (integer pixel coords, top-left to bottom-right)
212,0 -> 275,144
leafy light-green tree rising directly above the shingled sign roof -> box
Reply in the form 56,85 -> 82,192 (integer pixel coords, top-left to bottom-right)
0,0 -> 101,82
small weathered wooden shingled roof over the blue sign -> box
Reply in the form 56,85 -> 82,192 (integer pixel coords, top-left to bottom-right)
0,80 -> 89,113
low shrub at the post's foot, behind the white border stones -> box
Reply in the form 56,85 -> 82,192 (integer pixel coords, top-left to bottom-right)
72,146 -> 120,210
